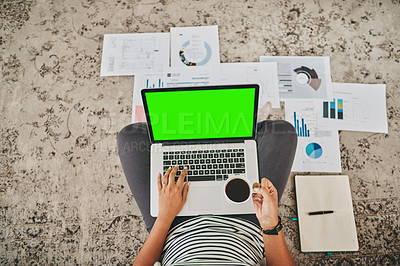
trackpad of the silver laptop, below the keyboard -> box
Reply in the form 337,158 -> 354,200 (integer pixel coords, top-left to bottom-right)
189,187 -> 221,211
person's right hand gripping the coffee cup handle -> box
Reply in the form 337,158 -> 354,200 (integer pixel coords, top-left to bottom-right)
253,178 -> 279,229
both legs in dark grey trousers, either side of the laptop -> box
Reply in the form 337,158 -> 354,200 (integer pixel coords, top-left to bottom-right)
118,120 -> 297,231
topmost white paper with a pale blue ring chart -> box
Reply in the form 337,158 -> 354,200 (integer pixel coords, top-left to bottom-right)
170,26 -> 220,67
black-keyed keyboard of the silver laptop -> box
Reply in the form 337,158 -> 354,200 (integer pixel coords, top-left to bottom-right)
163,149 -> 245,182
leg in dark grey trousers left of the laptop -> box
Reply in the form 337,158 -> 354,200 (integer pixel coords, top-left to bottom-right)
117,123 -> 156,231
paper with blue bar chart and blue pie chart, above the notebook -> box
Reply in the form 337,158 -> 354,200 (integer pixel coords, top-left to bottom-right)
285,100 -> 342,173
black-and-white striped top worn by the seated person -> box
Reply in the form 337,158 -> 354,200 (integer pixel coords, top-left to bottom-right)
161,216 -> 264,265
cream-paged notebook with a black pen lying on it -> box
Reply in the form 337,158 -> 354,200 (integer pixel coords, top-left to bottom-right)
295,175 -> 358,252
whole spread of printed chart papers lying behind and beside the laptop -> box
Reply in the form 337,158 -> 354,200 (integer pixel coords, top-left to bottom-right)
101,26 -> 388,173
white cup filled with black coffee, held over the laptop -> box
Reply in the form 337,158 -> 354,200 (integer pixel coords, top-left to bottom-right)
224,177 -> 251,204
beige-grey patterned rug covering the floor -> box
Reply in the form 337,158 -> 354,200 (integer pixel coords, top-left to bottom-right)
0,0 -> 400,265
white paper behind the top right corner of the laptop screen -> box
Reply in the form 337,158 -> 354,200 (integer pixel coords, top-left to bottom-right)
215,63 -> 280,108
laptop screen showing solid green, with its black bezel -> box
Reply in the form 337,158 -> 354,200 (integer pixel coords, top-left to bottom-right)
142,84 -> 259,142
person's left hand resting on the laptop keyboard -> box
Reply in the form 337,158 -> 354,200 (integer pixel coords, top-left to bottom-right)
157,165 -> 190,223
